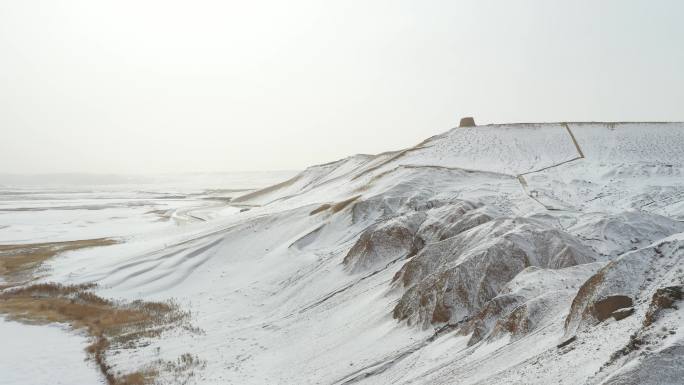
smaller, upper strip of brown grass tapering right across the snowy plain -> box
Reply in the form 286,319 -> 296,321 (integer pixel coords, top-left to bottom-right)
0,238 -> 117,283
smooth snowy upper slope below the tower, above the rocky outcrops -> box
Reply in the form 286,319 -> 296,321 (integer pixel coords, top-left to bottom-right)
238,123 -> 684,204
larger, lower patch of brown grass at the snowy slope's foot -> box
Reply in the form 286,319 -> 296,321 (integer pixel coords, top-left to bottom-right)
0,283 -> 199,385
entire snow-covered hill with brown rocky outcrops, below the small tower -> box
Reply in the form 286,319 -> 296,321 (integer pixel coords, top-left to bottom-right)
6,123 -> 684,384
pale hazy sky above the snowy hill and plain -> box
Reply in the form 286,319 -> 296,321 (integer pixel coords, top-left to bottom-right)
0,0 -> 684,173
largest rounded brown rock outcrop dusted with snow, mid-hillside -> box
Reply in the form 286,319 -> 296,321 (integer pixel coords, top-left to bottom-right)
393,218 -> 595,327
